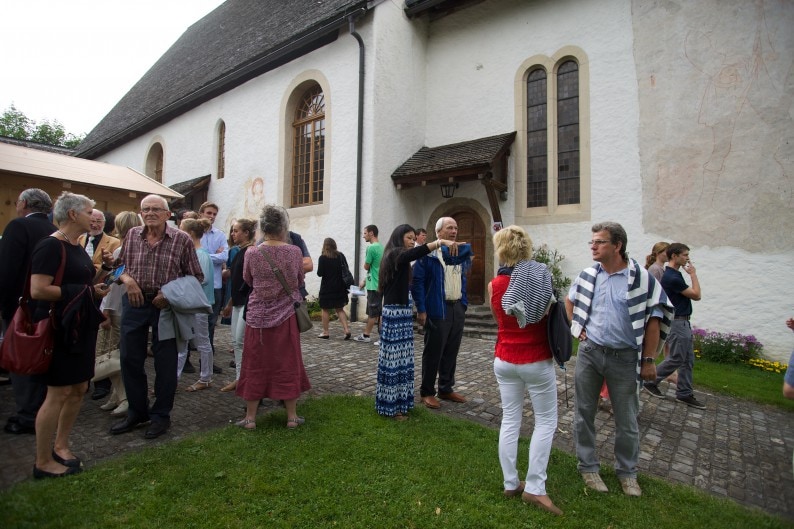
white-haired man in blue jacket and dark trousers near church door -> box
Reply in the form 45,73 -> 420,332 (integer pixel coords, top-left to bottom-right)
411,217 -> 472,409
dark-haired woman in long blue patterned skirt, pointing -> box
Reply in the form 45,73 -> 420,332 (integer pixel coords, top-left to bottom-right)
375,224 -> 457,421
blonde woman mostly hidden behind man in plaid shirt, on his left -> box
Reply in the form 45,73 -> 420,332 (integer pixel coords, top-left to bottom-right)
93,211 -> 143,417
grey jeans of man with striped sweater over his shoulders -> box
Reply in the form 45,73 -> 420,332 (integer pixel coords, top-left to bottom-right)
573,340 -> 640,478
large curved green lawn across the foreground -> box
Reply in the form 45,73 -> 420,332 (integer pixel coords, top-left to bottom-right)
0,396 -> 790,529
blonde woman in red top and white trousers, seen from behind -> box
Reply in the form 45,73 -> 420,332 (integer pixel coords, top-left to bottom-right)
488,226 -> 562,515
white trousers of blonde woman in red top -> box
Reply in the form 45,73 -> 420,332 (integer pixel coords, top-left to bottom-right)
494,358 -> 557,496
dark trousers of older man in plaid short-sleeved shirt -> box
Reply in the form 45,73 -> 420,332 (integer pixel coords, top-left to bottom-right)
120,294 -> 177,422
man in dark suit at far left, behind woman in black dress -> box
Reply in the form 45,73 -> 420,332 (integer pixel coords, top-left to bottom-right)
0,188 -> 56,434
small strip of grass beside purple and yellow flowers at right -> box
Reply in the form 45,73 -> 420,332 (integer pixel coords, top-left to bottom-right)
692,359 -> 794,411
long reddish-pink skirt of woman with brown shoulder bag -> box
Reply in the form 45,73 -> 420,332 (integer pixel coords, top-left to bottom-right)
236,316 -> 311,401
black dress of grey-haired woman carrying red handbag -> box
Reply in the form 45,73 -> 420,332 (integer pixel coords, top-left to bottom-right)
31,237 -> 99,386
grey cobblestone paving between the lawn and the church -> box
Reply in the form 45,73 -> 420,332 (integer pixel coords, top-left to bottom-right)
0,323 -> 794,519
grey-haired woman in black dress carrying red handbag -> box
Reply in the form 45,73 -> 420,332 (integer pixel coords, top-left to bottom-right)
30,191 -> 113,479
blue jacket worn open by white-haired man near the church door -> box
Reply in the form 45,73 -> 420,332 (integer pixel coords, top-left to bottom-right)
411,244 -> 472,320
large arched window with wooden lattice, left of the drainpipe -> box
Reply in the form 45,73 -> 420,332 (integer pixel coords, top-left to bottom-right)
291,85 -> 325,207
